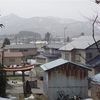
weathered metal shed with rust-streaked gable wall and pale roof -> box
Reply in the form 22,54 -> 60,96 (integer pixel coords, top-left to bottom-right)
40,58 -> 90,100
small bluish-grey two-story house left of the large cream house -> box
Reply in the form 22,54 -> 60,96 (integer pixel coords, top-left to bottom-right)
36,43 -> 63,64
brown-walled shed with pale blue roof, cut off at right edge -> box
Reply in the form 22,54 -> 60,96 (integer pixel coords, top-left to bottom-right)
88,73 -> 100,100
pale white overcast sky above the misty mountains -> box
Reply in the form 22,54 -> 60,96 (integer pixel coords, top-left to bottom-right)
0,0 -> 100,20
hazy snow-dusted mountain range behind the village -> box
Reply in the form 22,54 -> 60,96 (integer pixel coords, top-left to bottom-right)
0,14 -> 100,37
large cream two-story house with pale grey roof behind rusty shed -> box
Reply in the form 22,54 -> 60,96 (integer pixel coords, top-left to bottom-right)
59,36 -> 100,73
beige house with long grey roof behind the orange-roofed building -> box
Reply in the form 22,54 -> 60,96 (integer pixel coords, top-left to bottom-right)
3,44 -> 37,63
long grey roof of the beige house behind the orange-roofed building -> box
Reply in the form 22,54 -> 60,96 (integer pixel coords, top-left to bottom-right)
4,44 -> 37,49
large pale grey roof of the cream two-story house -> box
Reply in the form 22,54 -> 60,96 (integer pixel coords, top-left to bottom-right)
59,36 -> 100,51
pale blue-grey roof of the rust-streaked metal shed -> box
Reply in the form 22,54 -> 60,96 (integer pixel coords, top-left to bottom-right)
40,58 -> 91,71
